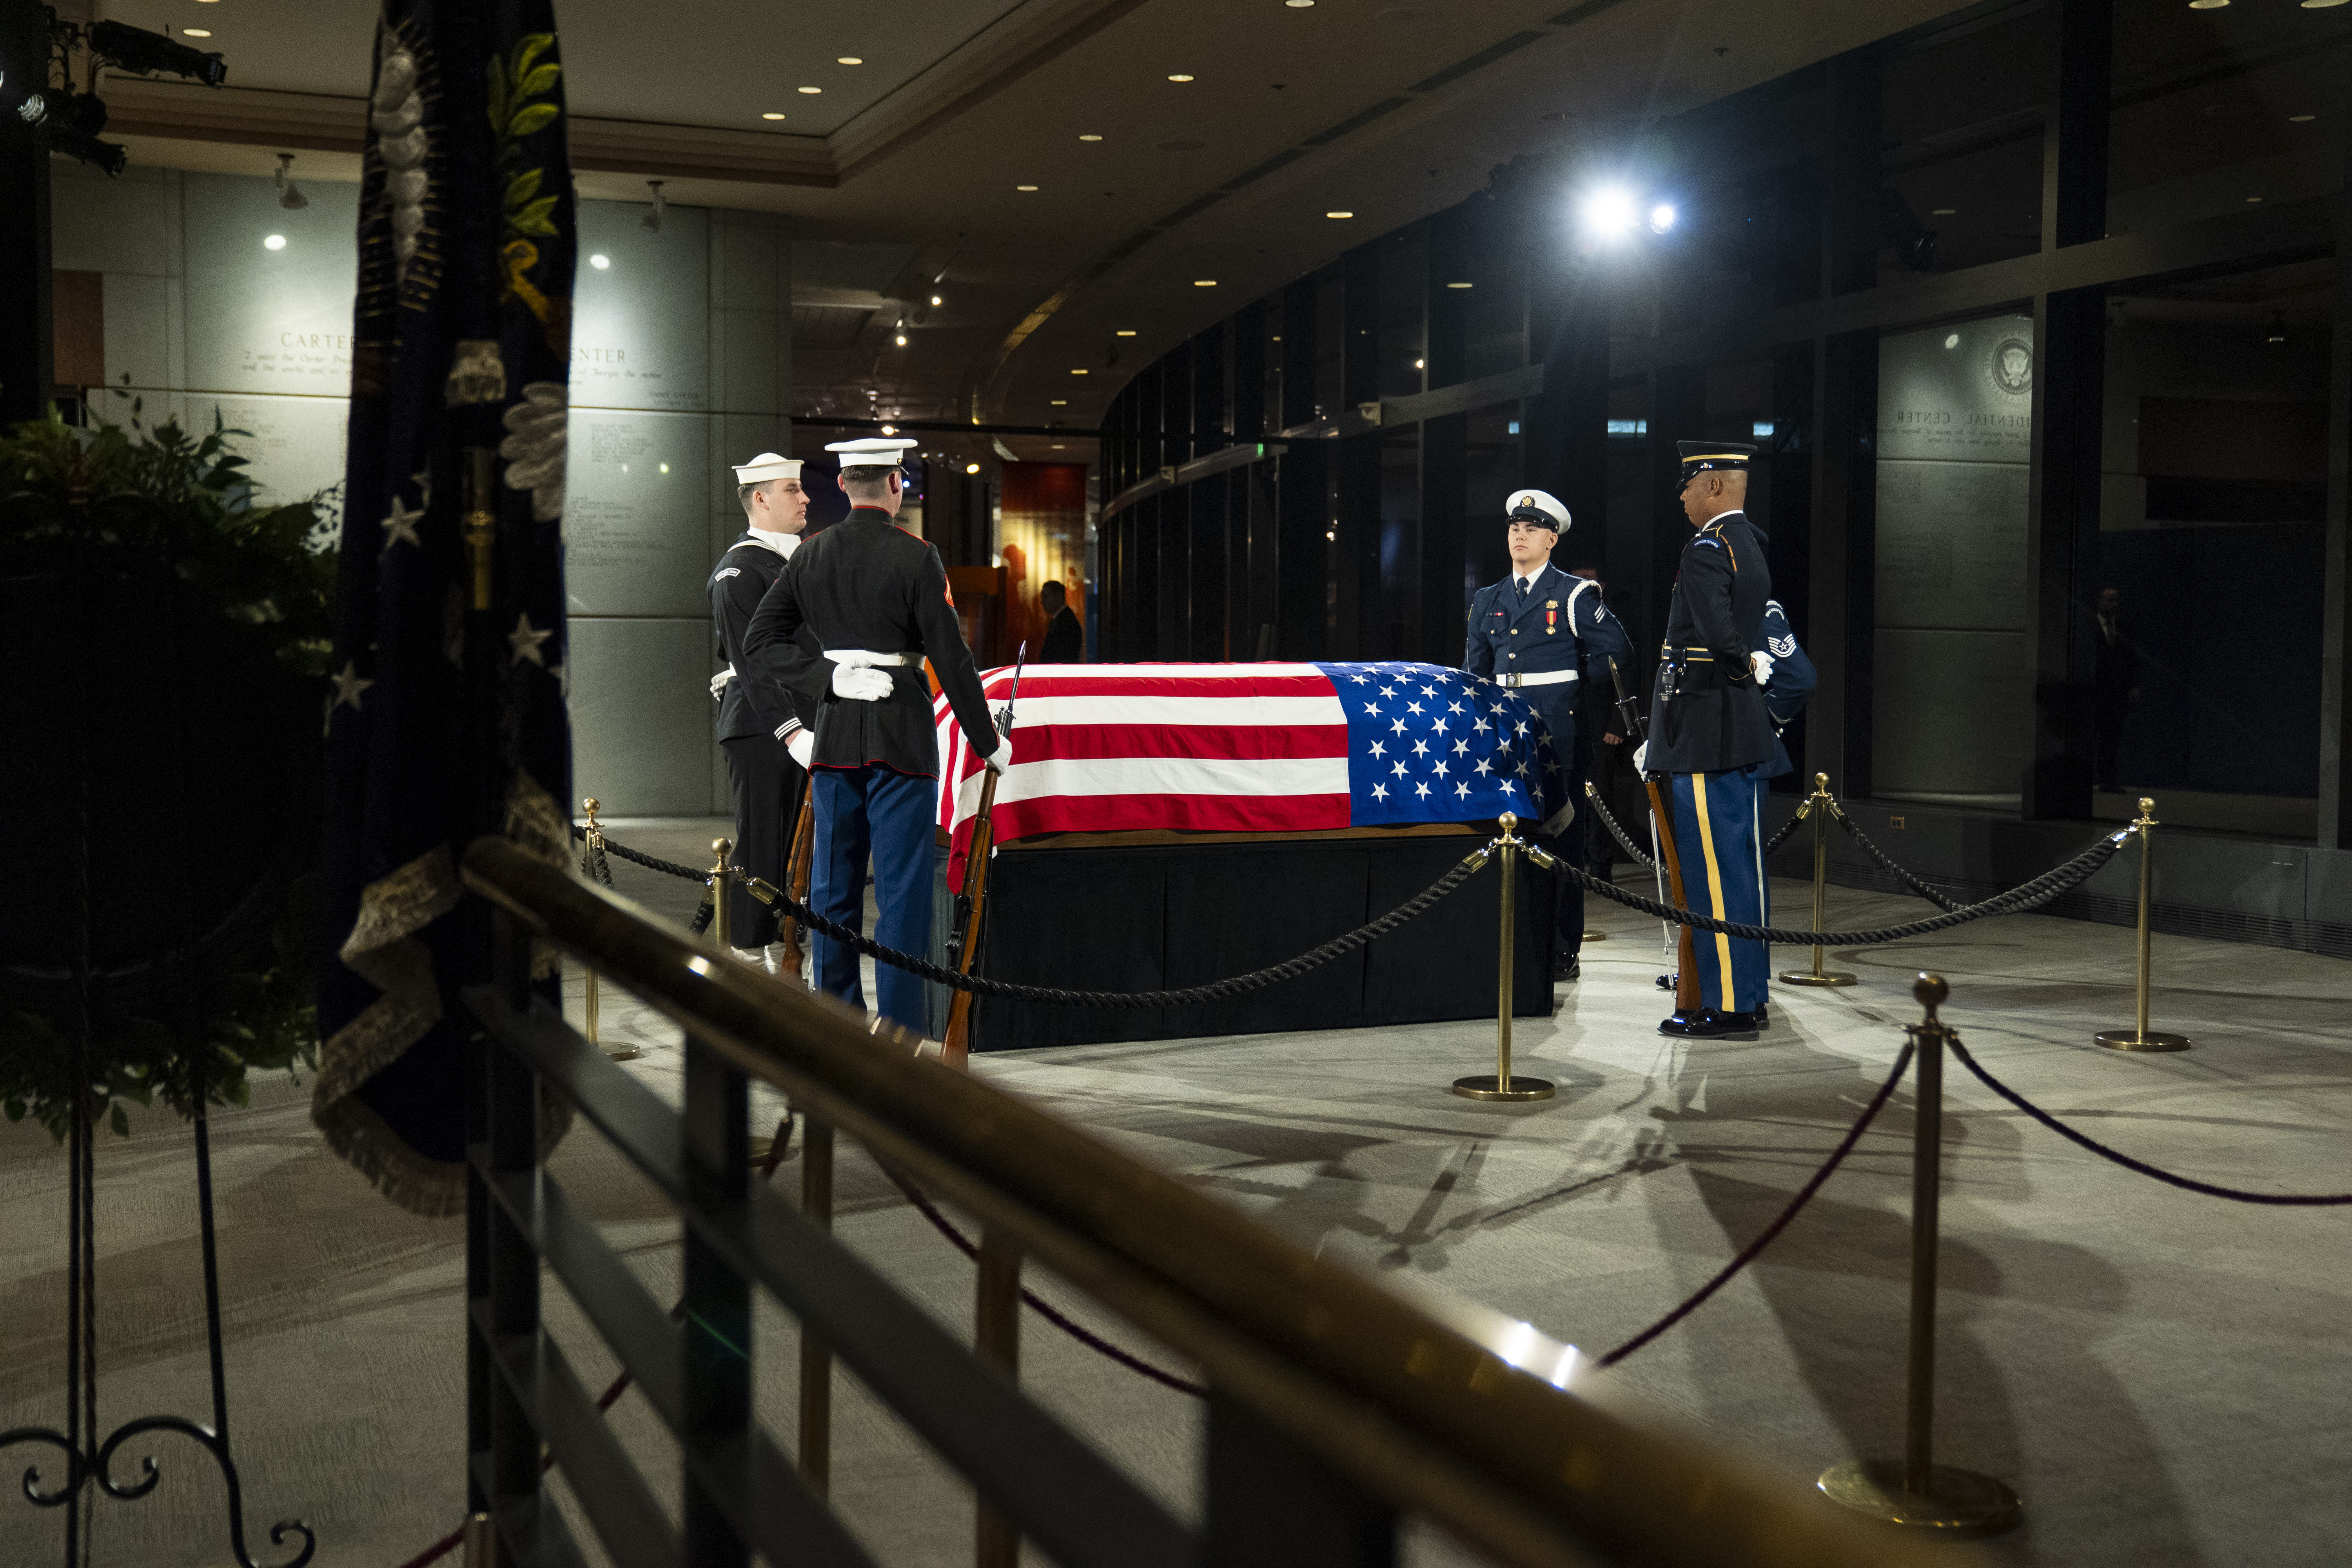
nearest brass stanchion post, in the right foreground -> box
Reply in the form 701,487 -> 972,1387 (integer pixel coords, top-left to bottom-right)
1820,973 -> 2018,1535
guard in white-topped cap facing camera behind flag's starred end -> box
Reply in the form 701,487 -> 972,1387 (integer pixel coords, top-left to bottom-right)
1463,489 -> 1632,980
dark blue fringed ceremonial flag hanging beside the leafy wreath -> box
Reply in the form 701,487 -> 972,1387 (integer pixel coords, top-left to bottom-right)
310,0 -> 574,1213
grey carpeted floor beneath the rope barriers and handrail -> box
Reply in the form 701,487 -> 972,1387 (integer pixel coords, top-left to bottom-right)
0,823 -> 2352,1568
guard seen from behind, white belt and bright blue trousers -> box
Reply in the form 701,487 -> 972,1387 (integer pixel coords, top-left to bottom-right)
748,437 -> 1011,1034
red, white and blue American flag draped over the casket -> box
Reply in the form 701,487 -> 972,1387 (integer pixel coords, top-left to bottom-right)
931,663 -> 1566,886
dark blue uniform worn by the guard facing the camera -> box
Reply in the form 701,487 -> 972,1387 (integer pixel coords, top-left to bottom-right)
1463,562 -> 1632,959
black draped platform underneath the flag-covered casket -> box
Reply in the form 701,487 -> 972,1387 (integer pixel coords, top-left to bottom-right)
971,830 -> 1552,1051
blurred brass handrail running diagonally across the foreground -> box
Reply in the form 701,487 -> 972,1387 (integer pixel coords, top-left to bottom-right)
463,839 -> 1955,1568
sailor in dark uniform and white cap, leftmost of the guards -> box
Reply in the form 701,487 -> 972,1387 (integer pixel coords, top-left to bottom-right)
710,451 -> 816,973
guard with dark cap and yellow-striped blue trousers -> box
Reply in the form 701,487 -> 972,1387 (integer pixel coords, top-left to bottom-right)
1635,442 -> 1773,1039
